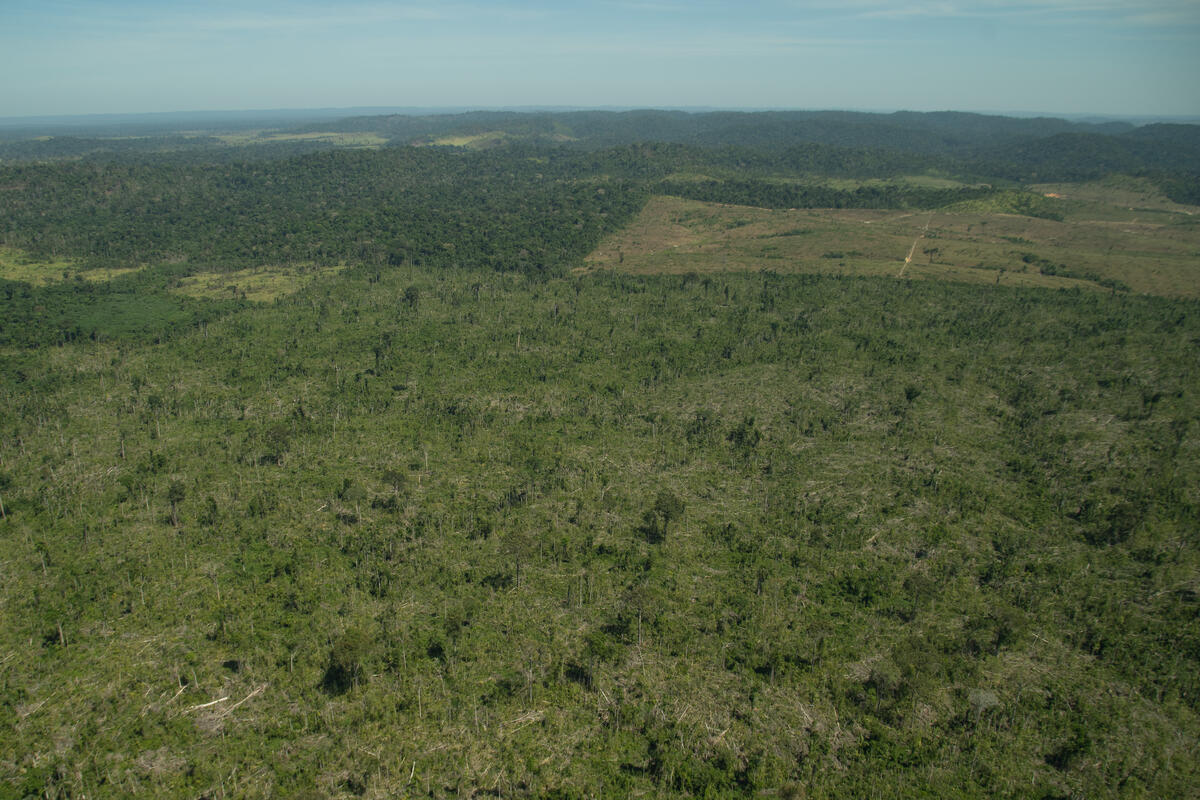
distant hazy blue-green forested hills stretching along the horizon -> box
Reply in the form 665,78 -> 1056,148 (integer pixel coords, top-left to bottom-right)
7,110 -> 1200,203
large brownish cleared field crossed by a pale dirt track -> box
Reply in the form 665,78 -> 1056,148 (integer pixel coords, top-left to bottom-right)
584,181 -> 1200,297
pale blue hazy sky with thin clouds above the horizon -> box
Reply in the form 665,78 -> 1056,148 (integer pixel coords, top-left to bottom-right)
0,0 -> 1200,116
